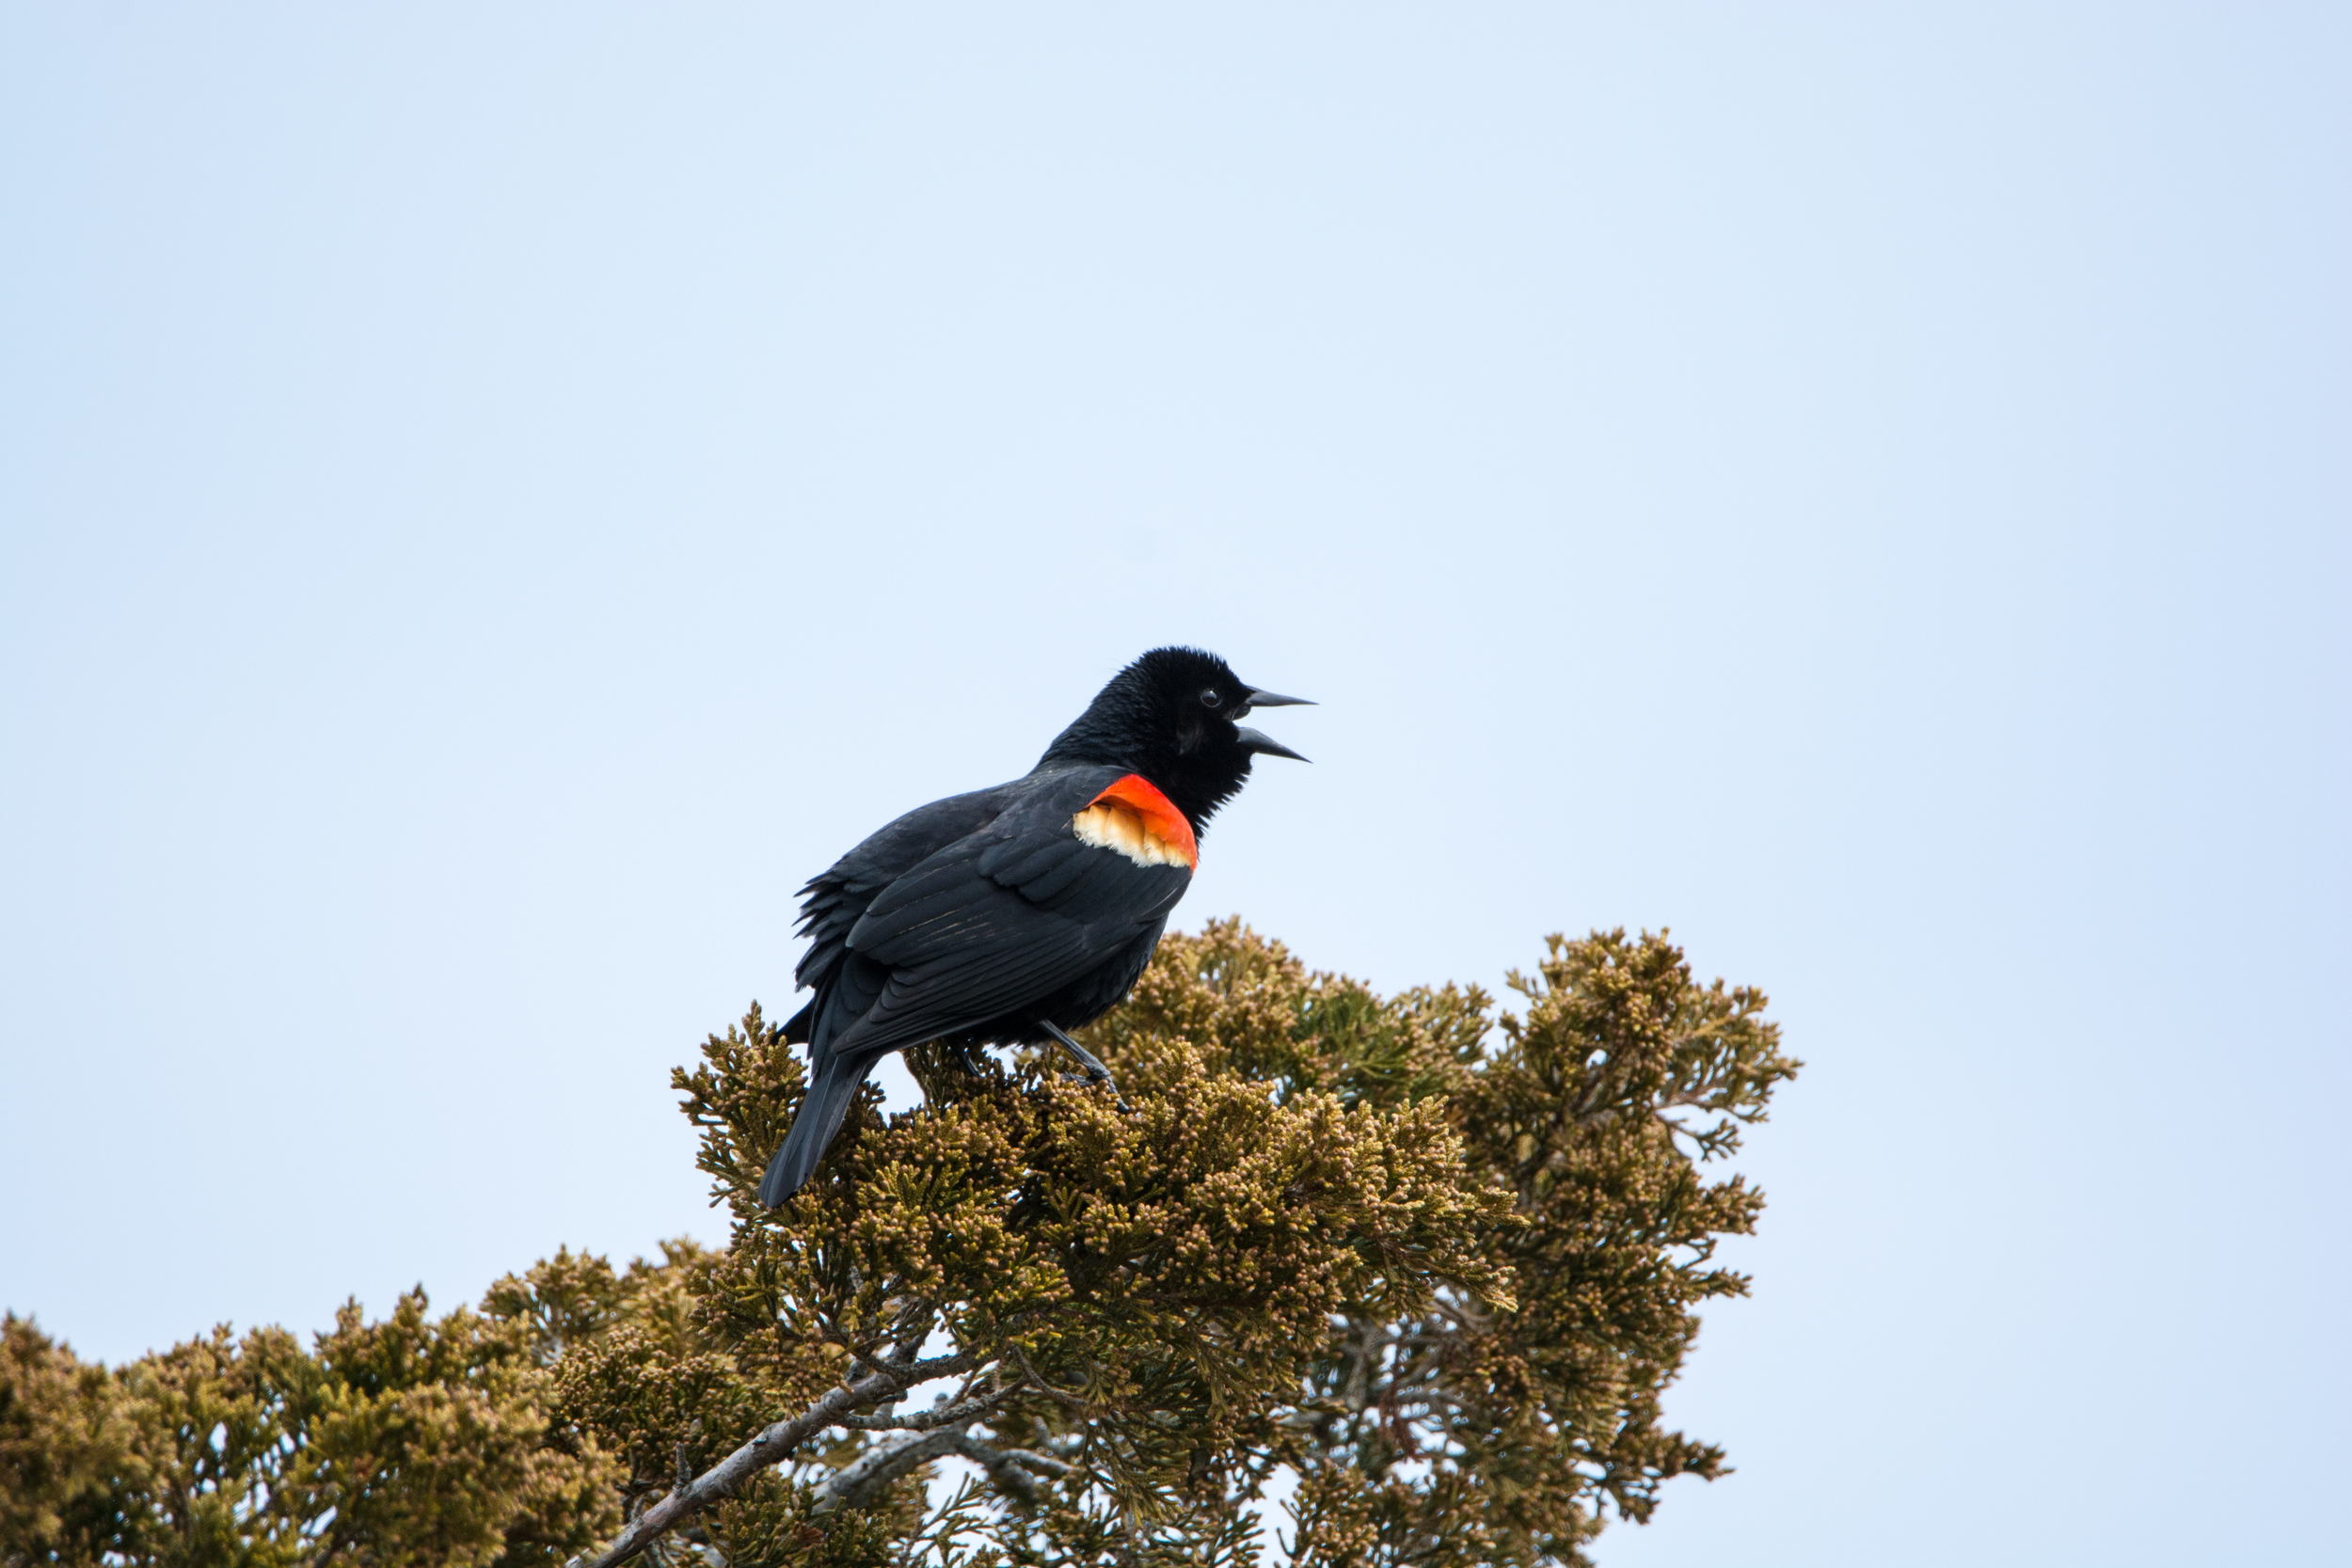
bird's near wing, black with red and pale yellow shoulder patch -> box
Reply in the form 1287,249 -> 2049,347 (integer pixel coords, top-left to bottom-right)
833,768 -> 1195,1053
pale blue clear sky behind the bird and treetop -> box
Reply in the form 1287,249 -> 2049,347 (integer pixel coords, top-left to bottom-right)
0,2 -> 2352,1568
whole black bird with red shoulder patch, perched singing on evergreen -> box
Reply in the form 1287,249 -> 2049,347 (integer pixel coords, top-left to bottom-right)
760,649 -> 1306,1209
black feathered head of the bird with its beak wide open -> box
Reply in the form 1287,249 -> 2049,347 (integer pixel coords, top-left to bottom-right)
1038,649 -> 1308,832
